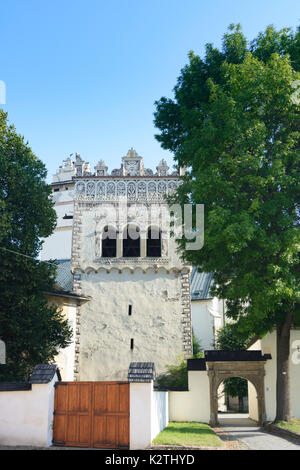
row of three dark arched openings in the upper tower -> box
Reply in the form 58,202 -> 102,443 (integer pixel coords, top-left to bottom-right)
102,224 -> 162,258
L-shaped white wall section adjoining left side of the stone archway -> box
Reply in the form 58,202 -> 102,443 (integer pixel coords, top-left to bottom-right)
169,371 -> 210,423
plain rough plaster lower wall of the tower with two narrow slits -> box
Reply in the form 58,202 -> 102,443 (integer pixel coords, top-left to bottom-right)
79,269 -> 183,380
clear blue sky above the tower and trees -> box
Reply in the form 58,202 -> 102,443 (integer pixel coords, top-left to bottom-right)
0,0 -> 300,180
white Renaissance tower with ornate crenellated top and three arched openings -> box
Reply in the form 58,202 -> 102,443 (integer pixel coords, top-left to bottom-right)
71,149 -> 192,381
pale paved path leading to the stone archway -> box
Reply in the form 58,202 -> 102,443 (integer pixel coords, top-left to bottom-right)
215,414 -> 300,450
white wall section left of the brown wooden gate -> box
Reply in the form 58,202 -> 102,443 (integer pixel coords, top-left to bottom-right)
0,374 -> 57,447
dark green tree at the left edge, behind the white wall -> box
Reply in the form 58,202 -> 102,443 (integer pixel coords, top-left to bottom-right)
0,110 -> 71,380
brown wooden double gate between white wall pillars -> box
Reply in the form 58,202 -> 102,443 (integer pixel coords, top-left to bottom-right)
53,382 -> 129,449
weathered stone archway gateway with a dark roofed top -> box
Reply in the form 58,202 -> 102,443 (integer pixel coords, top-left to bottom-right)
205,351 -> 271,426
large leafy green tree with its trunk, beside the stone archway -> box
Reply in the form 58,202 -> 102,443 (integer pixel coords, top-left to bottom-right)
155,26 -> 300,421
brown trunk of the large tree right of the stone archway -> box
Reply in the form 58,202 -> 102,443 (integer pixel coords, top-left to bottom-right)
275,313 -> 293,421
